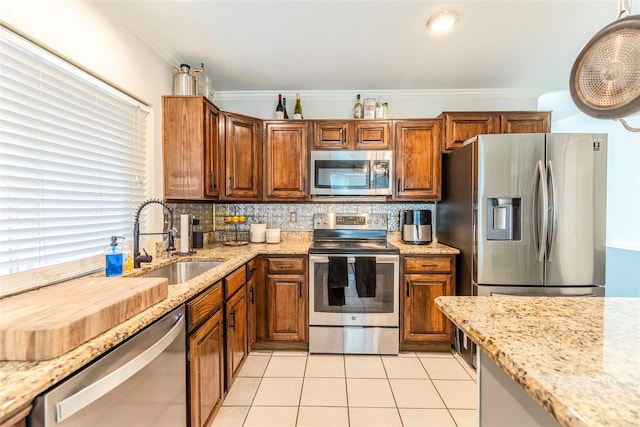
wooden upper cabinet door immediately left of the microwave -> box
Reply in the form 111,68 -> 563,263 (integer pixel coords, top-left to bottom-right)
264,122 -> 309,200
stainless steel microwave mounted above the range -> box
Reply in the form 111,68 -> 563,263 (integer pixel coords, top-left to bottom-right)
311,150 -> 393,196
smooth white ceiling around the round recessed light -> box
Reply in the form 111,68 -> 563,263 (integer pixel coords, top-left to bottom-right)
96,0 -> 618,91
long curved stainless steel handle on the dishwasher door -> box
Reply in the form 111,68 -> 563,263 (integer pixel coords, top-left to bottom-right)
56,313 -> 184,422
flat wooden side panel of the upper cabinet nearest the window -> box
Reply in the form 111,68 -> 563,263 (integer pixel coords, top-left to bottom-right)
162,96 -> 206,200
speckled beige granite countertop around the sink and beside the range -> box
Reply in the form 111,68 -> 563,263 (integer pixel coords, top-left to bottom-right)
0,239 -> 459,420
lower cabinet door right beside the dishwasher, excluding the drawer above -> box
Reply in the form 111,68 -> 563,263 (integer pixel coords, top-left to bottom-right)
189,310 -> 224,427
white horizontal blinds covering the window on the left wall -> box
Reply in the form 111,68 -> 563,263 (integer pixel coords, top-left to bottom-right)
0,27 -> 149,296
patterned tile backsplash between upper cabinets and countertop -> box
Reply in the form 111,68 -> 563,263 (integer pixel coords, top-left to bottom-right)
166,203 -> 435,240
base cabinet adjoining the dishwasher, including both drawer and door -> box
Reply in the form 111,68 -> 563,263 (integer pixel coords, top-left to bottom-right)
187,282 -> 224,427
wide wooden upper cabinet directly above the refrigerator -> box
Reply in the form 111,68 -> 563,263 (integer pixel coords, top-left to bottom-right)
438,111 -> 551,152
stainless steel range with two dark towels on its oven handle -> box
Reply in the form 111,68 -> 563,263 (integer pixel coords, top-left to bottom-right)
309,213 -> 400,354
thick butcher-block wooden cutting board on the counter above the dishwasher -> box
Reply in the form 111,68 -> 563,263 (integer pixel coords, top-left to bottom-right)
0,277 -> 169,360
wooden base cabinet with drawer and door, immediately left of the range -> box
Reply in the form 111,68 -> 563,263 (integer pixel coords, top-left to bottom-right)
266,256 -> 309,342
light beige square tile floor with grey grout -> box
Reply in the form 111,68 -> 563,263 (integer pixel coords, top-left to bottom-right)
213,351 -> 478,427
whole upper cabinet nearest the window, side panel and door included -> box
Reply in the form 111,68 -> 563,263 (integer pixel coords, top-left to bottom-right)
162,96 -> 221,200
